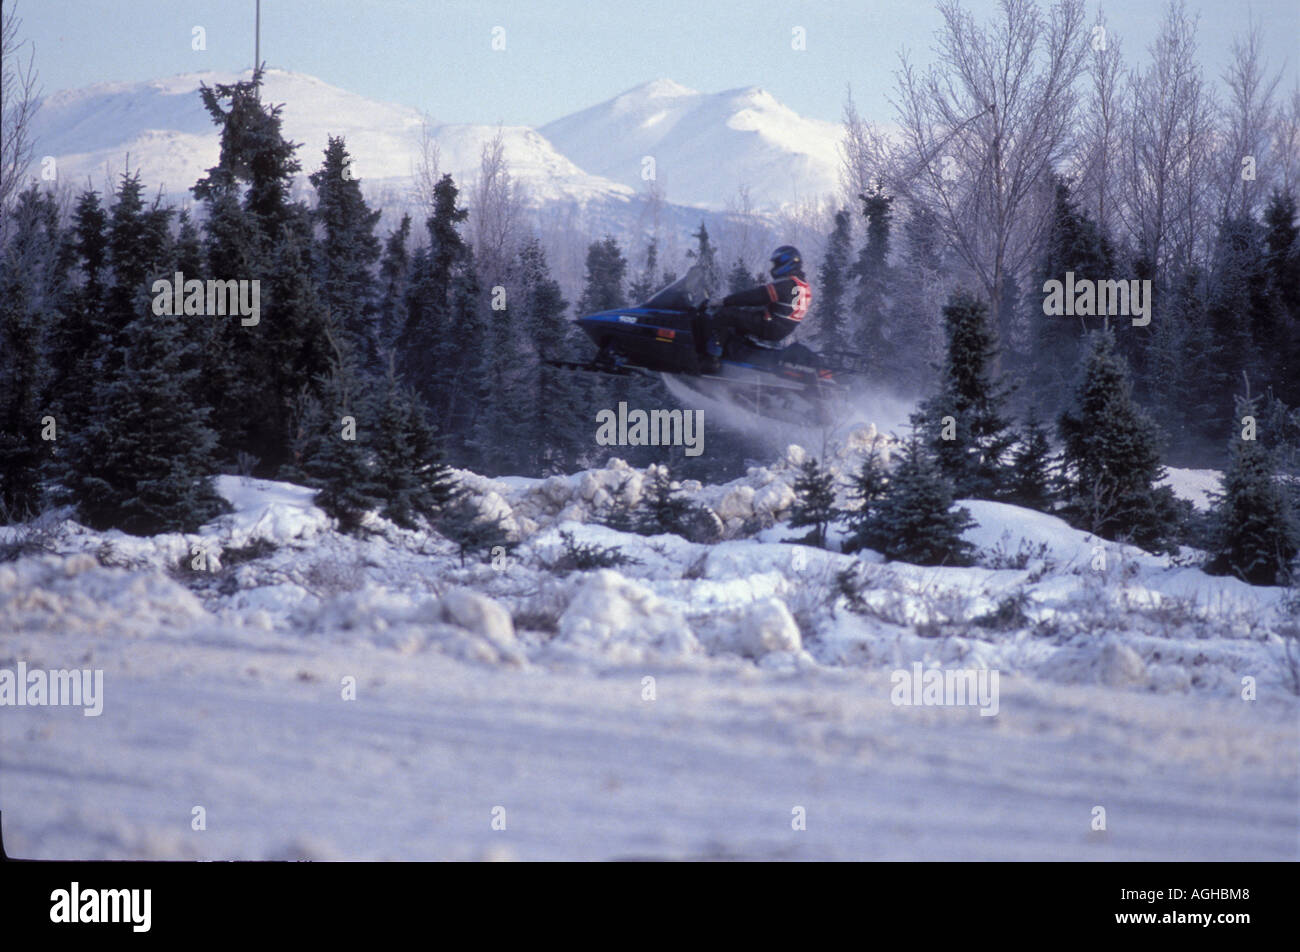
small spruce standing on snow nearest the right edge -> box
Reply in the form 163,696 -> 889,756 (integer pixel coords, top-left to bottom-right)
1206,397 -> 1300,585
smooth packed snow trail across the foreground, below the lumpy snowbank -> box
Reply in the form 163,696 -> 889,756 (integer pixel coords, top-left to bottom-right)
0,639 -> 1300,860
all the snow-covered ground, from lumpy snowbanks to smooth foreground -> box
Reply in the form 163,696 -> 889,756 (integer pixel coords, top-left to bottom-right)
0,430 -> 1300,860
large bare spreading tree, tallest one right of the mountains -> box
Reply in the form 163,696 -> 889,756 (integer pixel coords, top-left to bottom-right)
887,0 -> 1088,348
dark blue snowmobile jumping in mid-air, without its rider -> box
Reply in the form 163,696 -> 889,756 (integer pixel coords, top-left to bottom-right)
551,265 -> 866,425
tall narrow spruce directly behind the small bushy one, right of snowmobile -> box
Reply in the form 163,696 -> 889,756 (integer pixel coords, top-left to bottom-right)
914,291 -> 1014,499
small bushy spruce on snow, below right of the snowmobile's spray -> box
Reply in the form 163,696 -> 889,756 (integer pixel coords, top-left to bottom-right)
855,433 -> 975,566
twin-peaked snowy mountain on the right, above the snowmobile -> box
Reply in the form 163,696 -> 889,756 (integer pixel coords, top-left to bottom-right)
541,79 -> 840,208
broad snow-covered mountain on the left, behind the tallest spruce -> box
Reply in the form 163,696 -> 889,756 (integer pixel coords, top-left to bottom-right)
35,69 -> 631,210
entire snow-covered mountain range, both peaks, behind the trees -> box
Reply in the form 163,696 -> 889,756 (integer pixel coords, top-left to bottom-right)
35,69 -> 839,209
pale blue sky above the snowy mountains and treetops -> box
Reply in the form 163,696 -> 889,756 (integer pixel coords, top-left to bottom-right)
5,0 -> 1300,125
